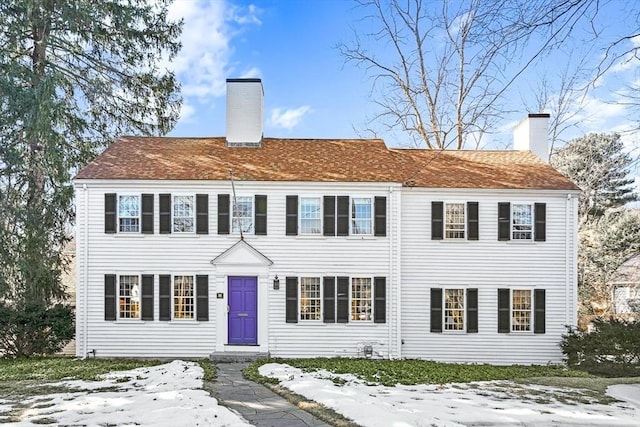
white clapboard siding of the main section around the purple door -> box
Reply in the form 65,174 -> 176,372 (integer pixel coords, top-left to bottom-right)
76,180 -> 399,357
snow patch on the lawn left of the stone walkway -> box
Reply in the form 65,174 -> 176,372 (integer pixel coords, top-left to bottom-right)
0,360 -> 250,427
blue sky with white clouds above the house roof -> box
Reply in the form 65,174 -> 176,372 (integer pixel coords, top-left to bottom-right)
164,0 -> 640,154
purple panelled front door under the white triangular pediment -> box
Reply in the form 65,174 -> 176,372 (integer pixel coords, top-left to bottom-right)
228,277 -> 258,345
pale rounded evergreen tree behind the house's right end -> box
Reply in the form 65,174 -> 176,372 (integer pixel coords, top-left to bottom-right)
551,133 -> 638,222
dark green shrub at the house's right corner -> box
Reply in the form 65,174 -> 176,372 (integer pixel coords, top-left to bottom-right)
560,318 -> 640,377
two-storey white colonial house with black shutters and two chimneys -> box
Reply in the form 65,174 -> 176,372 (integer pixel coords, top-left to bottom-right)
75,79 -> 578,364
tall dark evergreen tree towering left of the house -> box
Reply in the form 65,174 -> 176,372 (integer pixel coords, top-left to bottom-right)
0,0 -> 181,354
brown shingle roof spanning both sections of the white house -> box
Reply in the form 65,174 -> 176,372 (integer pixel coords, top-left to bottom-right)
76,137 -> 577,190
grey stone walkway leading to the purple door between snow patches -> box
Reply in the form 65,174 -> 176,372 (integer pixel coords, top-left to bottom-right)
212,363 -> 330,427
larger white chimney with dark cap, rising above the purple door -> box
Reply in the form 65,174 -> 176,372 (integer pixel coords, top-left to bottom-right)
227,79 -> 264,147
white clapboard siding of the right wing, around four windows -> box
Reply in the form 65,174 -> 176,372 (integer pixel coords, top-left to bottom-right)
401,189 -> 576,364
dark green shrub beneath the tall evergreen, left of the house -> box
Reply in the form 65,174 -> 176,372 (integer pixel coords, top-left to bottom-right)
0,303 -> 75,357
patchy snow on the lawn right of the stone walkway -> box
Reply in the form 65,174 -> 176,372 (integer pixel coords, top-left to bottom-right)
260,363 -> 640,427
